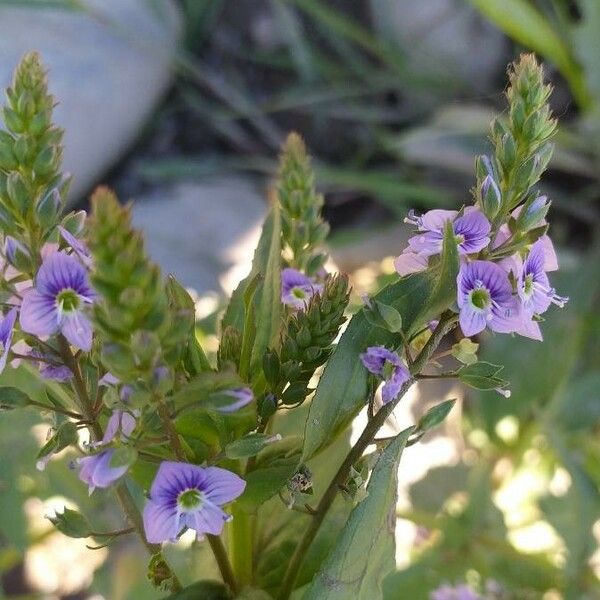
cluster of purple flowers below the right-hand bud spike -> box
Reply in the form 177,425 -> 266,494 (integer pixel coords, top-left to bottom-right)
395,200 -> 568,340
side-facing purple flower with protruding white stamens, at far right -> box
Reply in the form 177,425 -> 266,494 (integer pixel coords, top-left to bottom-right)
517,240 -> 569,317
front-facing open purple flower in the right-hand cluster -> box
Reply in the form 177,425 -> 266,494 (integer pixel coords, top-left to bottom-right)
457,260 -> 519,337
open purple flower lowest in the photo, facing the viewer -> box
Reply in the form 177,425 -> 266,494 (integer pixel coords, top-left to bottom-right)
144,462 -> 246,544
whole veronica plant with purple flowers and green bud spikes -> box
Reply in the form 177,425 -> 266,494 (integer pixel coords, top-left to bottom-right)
0,54 -> 566,600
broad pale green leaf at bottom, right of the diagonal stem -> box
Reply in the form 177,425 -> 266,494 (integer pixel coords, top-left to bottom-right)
302,427 -> 414,600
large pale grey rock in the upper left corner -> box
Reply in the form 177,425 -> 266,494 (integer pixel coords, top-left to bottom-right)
0,0 -> 181,200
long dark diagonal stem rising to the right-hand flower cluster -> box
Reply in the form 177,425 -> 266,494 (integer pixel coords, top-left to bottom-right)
279,313 -> 456,600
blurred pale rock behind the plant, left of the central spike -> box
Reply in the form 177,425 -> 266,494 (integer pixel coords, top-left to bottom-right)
133,177 -> 266,294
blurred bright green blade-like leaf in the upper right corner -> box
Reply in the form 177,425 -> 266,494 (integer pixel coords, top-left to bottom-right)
469,0 -> 589,107
